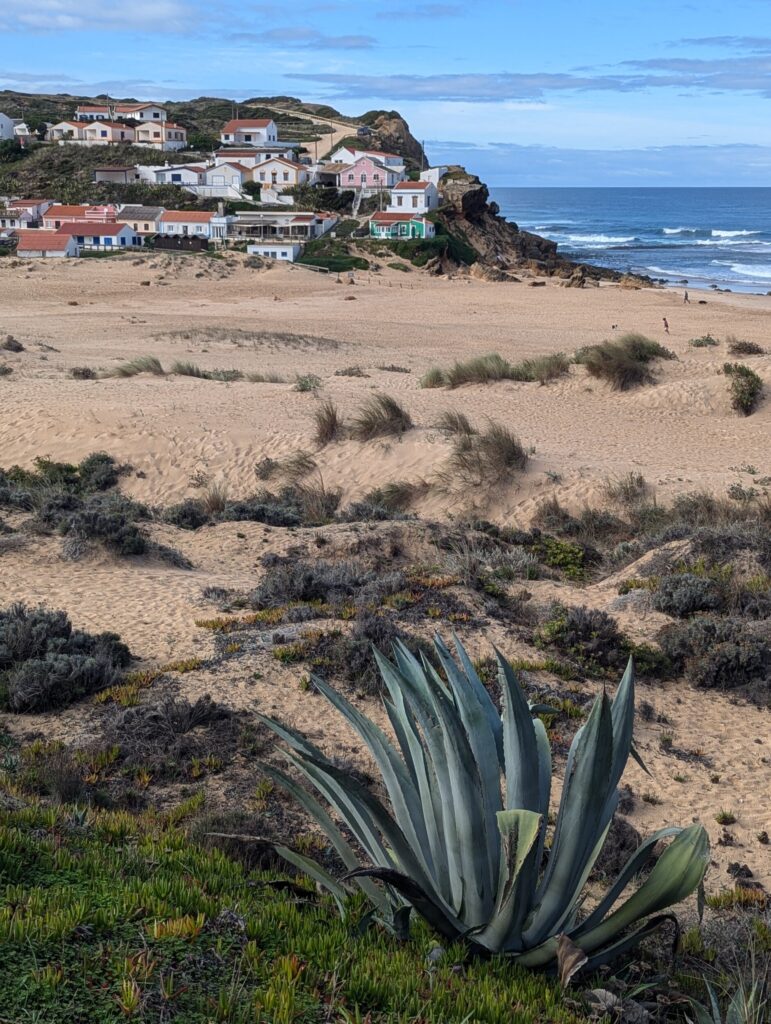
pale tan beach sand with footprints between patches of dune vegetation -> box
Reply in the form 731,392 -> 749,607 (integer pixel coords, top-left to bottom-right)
0,255 -> 771,889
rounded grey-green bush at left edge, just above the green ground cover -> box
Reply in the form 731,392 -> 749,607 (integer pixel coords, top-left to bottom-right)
0,604 -> 131,714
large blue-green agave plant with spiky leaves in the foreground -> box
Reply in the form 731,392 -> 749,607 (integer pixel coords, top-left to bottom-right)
262,638 -> 709,970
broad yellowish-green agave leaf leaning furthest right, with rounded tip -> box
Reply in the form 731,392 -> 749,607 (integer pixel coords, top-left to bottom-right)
581,825 -> 710,952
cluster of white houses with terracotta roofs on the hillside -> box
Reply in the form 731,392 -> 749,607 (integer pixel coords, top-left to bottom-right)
0,102 -> 446,261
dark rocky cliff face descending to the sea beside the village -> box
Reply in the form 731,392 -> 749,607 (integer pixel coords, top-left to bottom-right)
439,167 -> 647,288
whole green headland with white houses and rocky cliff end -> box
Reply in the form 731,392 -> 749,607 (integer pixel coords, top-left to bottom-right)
0,91 -> 626,278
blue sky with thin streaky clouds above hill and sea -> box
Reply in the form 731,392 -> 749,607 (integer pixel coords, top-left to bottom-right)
0,0 -> 771,185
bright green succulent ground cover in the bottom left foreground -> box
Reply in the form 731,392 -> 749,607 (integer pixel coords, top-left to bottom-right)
0,799 -> 583,1024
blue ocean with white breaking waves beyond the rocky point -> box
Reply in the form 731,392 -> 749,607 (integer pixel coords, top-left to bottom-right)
490,188 -> 771,294
